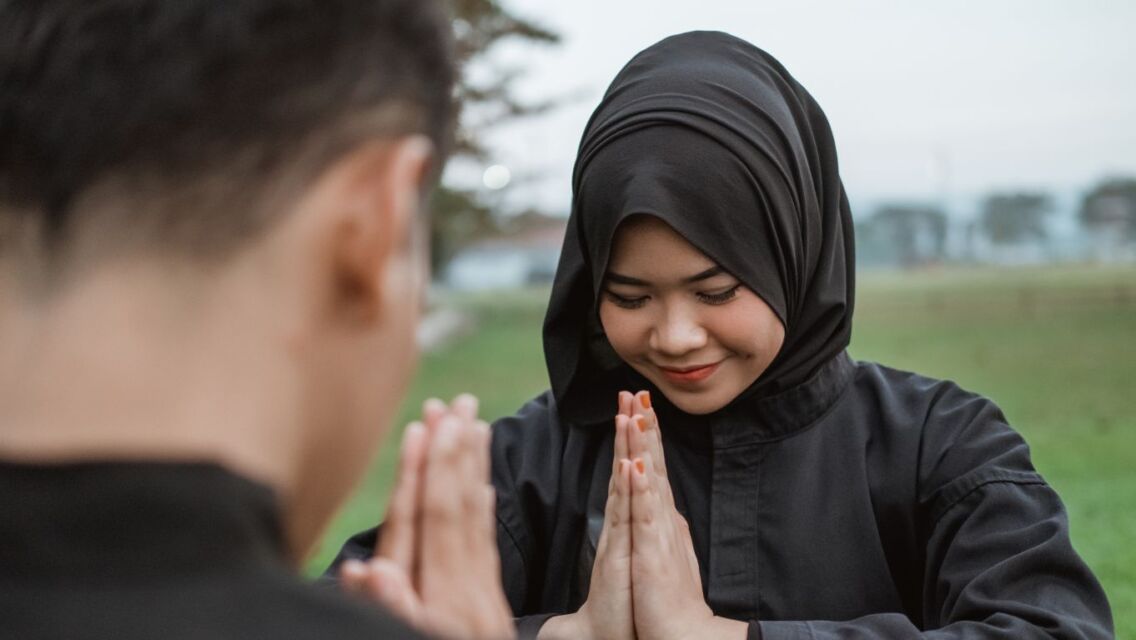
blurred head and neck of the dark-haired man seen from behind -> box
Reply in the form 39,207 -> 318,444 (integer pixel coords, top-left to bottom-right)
0,0 -> 453,561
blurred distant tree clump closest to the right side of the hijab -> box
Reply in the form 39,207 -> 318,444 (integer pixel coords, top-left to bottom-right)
857,203 -> 946,267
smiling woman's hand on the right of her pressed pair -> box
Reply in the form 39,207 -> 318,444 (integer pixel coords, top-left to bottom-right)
619,391 -> 749,640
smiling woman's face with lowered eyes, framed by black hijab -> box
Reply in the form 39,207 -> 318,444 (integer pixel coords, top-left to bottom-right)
600,216 -> 785,414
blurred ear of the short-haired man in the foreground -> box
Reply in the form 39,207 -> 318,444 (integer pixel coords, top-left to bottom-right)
331,135 -> 433,322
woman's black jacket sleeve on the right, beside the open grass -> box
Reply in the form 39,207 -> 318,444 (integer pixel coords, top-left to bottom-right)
751,384 -> 1113,640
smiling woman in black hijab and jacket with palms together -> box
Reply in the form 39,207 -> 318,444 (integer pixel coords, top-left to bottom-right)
329,32 -> 1112,640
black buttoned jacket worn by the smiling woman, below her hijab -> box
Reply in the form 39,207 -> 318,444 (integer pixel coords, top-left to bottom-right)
337,355 -> 1112,640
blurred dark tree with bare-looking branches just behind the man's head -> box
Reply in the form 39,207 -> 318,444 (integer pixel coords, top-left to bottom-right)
431,0 -> 560,273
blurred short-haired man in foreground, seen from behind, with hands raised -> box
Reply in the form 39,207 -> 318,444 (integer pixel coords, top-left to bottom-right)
0,0 -> 512,639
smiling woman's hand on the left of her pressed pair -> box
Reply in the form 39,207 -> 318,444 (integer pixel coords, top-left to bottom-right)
537,393 -> 635,640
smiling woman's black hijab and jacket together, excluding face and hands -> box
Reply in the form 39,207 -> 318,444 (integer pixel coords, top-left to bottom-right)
327,33 -> 1112,640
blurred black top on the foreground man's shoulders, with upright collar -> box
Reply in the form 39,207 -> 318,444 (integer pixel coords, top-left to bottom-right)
0,463 -> 419,640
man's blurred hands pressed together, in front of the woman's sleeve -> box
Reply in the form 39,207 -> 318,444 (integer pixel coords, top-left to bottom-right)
340,396 -> 516,640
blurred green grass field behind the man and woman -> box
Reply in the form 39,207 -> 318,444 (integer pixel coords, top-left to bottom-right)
310,267 -> 1136,639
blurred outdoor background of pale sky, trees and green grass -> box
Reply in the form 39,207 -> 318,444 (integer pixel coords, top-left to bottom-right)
309,0 -> 1136,638
